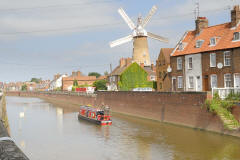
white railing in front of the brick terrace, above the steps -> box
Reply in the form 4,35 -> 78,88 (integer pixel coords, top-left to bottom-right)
212,87 -> 240,99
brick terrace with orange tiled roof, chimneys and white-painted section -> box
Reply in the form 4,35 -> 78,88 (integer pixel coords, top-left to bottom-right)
170,6 -> 240,91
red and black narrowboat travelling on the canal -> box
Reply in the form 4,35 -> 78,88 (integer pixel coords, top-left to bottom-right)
78,106 -> 112,125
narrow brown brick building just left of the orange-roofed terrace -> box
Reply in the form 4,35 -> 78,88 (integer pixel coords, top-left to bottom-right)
156,48 -> 174,92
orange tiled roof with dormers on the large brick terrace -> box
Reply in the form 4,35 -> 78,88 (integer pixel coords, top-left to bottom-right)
171,23 -> 240,56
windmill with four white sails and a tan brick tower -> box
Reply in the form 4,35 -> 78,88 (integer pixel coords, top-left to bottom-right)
110,5 -> 168,66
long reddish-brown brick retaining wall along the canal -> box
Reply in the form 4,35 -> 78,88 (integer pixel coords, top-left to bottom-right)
8,92 -> 240,137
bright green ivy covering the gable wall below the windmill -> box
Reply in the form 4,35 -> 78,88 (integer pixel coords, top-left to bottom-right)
118,63 -> 153,91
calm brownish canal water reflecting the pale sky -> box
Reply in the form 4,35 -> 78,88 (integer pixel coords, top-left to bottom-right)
7,97 -> 240,160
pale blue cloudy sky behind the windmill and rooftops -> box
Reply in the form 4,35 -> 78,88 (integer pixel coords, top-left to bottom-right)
0,0 -> 240,82
